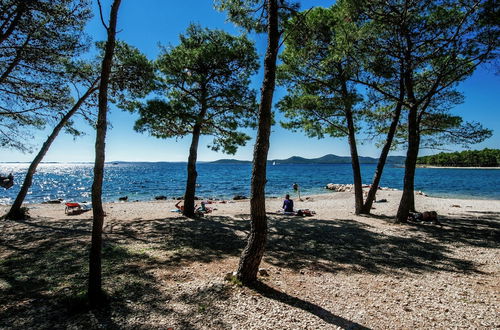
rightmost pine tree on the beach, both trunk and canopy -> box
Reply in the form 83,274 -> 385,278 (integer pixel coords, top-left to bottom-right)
352,0 -> 500,222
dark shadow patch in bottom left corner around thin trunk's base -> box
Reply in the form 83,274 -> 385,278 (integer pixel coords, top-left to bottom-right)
0,220 -> 168,329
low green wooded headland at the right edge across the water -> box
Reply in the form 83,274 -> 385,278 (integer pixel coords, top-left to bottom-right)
417,148 -> 500,167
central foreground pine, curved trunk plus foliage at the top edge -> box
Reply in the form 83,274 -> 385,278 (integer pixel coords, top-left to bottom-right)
217,0 -> 297,284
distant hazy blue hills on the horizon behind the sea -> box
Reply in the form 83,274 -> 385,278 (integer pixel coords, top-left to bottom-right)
212,154 -> 406,165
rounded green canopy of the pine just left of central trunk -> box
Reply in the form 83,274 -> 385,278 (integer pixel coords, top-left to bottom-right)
135,25 -> 258,154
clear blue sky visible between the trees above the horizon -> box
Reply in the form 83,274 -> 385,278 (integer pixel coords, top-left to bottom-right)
0,0 -> 500,162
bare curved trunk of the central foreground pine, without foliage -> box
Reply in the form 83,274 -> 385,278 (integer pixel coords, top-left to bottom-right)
237,0 -> 280,284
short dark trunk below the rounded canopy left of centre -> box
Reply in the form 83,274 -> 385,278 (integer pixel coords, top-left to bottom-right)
183,123 -> 201,218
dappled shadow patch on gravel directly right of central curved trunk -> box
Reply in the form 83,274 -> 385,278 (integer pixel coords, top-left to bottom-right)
265,218 -> 476,273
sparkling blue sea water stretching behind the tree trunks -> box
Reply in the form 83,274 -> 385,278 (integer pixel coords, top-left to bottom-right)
0,163 -> 500,204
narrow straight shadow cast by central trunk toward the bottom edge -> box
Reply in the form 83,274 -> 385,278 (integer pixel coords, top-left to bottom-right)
250,281 -> 369,330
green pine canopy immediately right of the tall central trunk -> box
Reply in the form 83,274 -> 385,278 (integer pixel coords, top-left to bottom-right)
278,6 -> 362,138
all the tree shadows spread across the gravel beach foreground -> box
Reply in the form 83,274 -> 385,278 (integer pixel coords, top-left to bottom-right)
0,212 -> 500,328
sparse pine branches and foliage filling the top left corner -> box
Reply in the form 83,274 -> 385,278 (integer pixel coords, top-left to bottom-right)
0,0 -> 91,151
